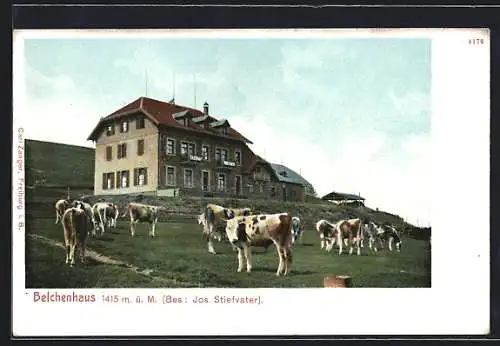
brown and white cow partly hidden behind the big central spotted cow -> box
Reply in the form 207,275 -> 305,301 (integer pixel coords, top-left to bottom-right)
198,203 -> 252,255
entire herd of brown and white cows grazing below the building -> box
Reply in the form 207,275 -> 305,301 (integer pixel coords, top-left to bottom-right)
55,200 -> 402,276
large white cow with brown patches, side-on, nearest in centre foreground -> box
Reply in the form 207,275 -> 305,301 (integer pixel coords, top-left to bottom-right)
226,213 -> 292,276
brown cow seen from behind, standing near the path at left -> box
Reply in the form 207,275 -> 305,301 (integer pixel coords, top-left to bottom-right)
62,207 -> 89,267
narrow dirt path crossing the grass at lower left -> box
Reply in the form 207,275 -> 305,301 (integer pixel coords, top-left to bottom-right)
27,233 -> 197,287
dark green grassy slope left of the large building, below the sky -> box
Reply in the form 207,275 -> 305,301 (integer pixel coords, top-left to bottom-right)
25,139 -> 95,189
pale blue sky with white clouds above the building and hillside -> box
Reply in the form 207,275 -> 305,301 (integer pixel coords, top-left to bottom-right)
21,36 -> 432,226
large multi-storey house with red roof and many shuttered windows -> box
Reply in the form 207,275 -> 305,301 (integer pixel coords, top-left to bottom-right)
88,97 -> 305,201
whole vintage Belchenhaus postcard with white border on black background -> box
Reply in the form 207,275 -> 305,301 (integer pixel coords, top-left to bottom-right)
12,29 -> 490,336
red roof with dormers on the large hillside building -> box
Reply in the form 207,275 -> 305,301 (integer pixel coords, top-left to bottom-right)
88,97 -> 252,144
